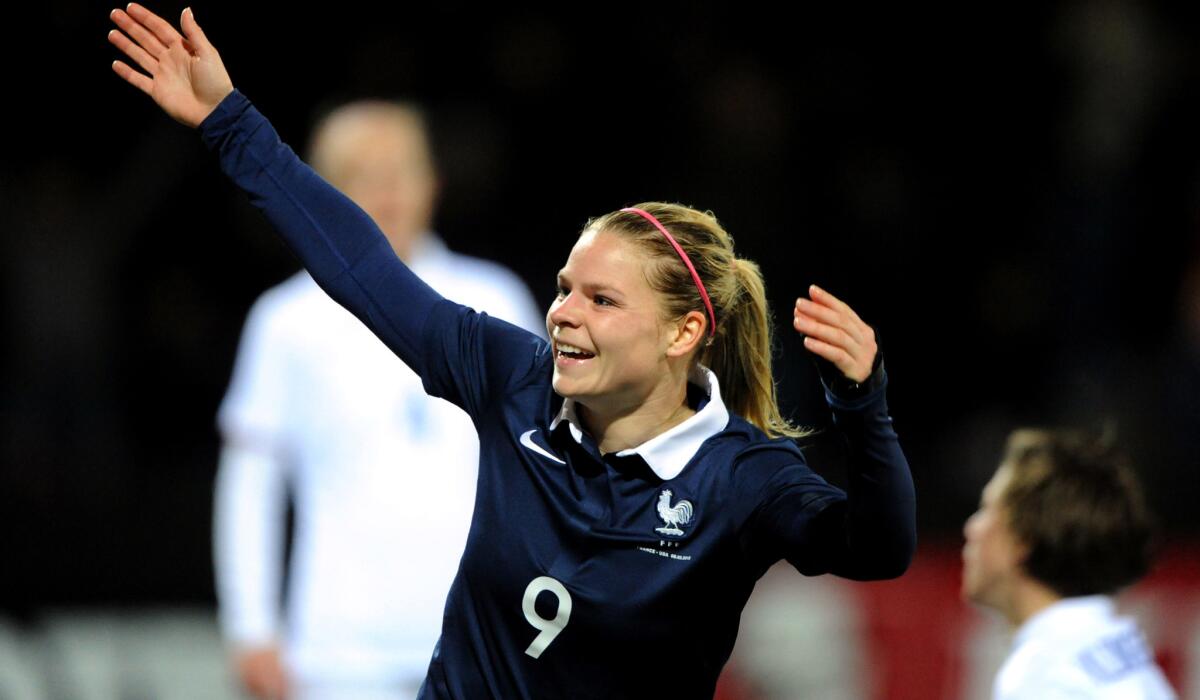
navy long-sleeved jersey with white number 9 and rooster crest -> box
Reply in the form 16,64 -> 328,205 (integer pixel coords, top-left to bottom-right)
200,91 -> 916,699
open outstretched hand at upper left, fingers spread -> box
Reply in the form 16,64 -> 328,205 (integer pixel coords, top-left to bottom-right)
108,2 -> 233,128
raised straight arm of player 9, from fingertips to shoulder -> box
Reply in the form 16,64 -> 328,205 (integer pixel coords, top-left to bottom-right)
109,4 -> 545,415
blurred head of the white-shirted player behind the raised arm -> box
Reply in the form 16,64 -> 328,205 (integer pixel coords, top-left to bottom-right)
310,102 -> 437,259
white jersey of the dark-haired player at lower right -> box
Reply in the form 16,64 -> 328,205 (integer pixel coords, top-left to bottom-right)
992,596 -> 1175,700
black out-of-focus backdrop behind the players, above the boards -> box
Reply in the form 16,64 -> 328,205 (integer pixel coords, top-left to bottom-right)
0,1 -> 1200,618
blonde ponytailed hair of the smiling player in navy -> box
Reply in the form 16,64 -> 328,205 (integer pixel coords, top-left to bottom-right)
583,202 -> 808,437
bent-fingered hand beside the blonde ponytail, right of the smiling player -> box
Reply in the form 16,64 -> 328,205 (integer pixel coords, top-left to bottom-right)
792,285 -> 880,383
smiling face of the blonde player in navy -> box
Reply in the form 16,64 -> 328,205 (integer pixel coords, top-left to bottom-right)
546,231 -> 678,414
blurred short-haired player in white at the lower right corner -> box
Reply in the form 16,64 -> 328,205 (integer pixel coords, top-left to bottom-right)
962,430 -> 1175,700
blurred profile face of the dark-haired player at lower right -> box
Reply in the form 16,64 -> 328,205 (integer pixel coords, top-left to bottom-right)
962,465 -> 1025,611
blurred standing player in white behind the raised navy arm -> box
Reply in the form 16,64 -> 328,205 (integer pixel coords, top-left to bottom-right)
215,101 -> 545,699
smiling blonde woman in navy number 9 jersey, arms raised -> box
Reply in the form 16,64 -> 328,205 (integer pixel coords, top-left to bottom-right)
109,4 -> 916,698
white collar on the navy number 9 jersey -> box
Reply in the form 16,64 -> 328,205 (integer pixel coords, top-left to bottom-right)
550,365 -> 730,481
